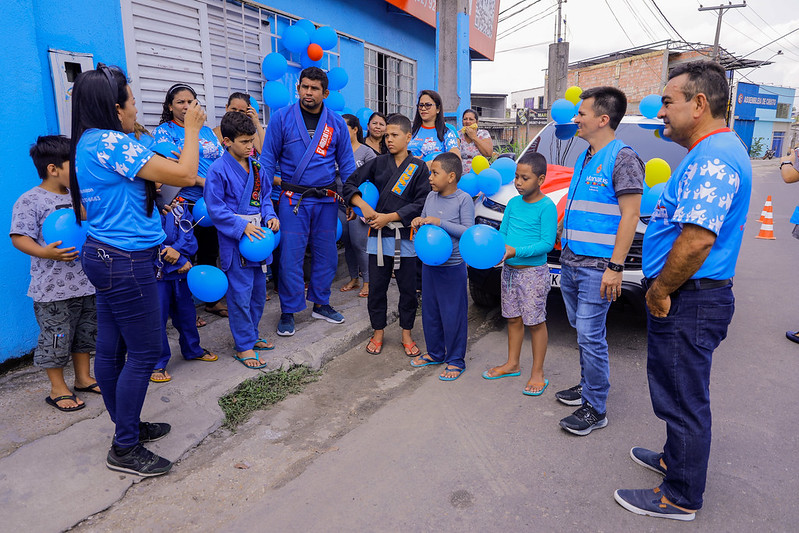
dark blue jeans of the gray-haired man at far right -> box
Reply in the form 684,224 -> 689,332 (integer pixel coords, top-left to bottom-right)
647,285 -> 735,509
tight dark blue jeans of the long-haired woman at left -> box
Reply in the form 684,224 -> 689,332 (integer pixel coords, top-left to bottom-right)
81,237 -> 163,447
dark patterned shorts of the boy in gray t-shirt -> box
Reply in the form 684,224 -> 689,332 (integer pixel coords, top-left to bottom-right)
33,294 -> 97,368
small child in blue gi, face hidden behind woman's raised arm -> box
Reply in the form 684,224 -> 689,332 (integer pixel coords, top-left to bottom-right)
150,198 -> 219,383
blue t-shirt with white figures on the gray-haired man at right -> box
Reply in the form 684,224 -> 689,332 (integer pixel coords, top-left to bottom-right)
643,128 -> 752,280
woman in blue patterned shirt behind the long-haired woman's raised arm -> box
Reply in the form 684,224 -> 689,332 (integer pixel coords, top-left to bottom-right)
153,83 -> 227,316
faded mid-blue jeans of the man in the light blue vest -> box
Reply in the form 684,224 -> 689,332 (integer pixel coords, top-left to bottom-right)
560,265 -> 610,413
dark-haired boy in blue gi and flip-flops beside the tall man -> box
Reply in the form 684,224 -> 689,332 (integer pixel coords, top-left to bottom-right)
203,111 -> 285,369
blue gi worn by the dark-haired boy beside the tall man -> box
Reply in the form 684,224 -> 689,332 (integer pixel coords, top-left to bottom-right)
203,152 -> 277,352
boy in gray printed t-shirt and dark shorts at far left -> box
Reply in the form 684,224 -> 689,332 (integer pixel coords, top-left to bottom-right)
9,135 -> 100,411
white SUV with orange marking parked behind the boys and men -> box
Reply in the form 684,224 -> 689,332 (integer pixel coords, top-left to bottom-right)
469,115 -> 687,312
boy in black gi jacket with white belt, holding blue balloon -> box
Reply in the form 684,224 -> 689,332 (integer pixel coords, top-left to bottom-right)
344,115 -> 432,357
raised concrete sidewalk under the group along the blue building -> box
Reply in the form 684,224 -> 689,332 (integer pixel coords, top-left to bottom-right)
0,261 -> 397,531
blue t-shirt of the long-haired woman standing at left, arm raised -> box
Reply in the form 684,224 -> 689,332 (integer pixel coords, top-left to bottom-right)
75,129 -> 165,251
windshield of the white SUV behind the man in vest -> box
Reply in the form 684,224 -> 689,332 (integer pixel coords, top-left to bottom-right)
525,122 -> 686,168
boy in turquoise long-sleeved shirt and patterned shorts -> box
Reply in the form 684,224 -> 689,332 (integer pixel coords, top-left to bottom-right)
483,152 -> 558,396
